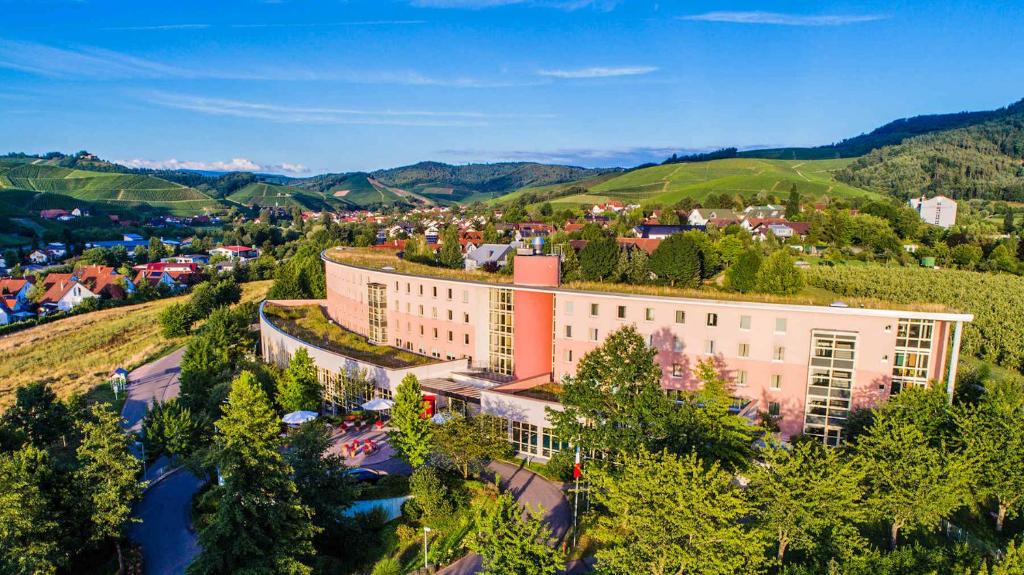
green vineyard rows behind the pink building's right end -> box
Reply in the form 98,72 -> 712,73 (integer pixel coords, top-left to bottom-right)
805,266 -> 1024,370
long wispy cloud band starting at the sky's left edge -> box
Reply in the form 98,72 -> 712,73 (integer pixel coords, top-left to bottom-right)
0,40 -> 539,88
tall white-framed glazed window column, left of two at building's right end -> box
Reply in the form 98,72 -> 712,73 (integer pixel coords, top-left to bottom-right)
804,330 -> 857,445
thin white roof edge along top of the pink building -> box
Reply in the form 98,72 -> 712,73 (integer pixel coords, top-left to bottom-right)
321,248 -> 974,321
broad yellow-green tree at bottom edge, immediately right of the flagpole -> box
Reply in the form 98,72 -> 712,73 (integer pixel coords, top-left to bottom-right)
589,451 -> 767,575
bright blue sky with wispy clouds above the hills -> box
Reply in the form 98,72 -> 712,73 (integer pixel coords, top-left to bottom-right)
0,0 -> 1024,174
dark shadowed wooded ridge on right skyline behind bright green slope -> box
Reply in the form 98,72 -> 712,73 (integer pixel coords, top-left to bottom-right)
738,99 -> 1024,160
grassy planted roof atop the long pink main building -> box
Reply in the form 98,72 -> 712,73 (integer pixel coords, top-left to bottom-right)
323,243 -> 954,313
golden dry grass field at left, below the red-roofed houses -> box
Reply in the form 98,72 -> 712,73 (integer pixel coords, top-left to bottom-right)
0,281 -> 270,410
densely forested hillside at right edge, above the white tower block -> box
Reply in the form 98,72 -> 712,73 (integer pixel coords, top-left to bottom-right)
836,108 -> 1024,202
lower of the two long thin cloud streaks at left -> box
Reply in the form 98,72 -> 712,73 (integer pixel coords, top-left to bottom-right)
144,92 -> 552,128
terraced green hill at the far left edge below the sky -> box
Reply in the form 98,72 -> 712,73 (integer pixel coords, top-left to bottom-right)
0,159 -> 222,214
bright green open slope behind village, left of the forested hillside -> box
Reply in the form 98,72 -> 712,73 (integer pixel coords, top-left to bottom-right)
500,158 -> 878,206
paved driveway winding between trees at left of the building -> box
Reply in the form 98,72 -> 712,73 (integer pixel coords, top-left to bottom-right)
121,348 -> 203,575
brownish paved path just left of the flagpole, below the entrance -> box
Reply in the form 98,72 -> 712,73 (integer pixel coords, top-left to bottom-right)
438,461 -> 572,575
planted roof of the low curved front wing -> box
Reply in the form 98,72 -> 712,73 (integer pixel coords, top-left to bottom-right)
263,303 -> 437,369
